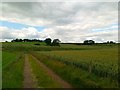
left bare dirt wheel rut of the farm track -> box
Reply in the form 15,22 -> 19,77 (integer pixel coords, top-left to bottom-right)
23,54 -> 37,88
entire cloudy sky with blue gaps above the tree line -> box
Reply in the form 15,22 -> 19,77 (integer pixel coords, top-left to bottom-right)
0,2 -> 118,43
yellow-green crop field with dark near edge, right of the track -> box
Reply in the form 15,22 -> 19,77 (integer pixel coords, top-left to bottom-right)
37,47 -> 118,80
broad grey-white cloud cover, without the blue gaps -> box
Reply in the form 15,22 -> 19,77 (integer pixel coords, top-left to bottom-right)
2,2 -> 118,42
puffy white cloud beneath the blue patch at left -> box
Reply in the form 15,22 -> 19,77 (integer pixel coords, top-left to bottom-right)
0,27 -> 40,39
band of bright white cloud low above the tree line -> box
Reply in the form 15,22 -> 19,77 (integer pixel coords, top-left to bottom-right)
0,24 -> 118,43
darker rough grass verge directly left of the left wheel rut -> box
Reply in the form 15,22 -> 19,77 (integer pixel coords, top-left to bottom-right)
2,52 -> 24,88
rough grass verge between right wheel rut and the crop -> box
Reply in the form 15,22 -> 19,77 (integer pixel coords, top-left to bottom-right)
33,52 -> 117,88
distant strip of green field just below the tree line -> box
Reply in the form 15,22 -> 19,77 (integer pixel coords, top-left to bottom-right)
2,42 -> 117,51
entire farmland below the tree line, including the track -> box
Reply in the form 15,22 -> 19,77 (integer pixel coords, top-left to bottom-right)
2,42 -> 118,88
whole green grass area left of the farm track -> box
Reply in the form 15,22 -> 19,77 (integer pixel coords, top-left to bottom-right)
2,51 -> 24,88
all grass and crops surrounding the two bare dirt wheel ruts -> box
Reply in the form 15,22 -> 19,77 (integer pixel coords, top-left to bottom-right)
0,42 -> 118,88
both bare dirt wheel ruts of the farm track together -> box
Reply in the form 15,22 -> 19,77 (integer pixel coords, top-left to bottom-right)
23,54 -> 72,88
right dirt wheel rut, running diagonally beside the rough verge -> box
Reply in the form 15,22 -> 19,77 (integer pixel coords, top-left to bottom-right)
31,55 -> 72,88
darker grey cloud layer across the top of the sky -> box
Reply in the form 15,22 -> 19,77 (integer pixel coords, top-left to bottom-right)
3,2 -> 117,25
